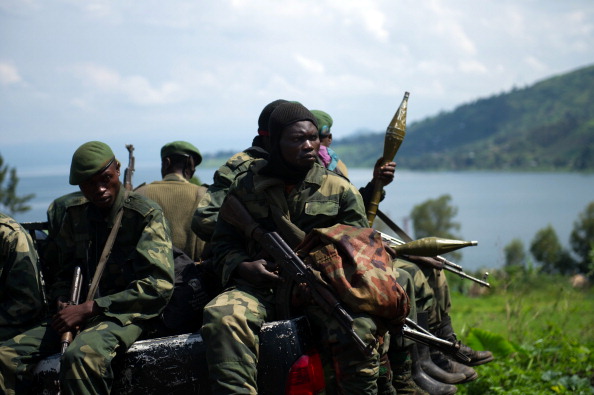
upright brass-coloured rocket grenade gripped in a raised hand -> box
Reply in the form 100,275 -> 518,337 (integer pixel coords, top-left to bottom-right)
367,92 -> 409,227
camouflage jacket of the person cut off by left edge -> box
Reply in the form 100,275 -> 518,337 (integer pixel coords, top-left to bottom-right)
0,213 -> 47,343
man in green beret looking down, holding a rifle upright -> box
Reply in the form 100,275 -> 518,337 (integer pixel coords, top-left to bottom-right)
0,141 -> 173,395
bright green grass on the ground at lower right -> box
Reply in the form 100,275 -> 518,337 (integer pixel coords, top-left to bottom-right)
448,270 -> 594,395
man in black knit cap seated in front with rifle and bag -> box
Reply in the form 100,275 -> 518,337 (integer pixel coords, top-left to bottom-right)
202,103 -> 379,394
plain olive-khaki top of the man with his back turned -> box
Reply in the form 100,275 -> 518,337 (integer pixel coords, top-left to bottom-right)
135,173 -> 206,262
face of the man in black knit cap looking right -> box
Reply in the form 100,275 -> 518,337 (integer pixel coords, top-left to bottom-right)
279,121 -> 320,168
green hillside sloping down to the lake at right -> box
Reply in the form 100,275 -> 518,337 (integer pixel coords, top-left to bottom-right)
332,66 -> 594,171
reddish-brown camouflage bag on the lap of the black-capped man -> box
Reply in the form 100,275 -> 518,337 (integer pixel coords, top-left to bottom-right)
297,224 -> 410,328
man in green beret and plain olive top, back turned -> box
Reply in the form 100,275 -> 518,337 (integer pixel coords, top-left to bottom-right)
135,141 -> 206,262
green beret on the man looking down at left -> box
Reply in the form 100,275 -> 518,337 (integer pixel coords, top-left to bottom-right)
69,141 -> 115,185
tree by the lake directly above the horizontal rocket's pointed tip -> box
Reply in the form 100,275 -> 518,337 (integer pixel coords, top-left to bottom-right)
410,194 -> 462,259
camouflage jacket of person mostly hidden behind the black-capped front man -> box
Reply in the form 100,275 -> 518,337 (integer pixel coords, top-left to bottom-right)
192,147 -> 268,241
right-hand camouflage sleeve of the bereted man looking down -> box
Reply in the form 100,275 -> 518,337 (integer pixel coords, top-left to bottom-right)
95,208 -> 174,325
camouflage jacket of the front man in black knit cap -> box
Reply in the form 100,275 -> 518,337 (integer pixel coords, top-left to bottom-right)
212,159 -> 368,285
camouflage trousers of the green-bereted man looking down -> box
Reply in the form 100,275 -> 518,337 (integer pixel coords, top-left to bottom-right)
0,316 -> 142,395
